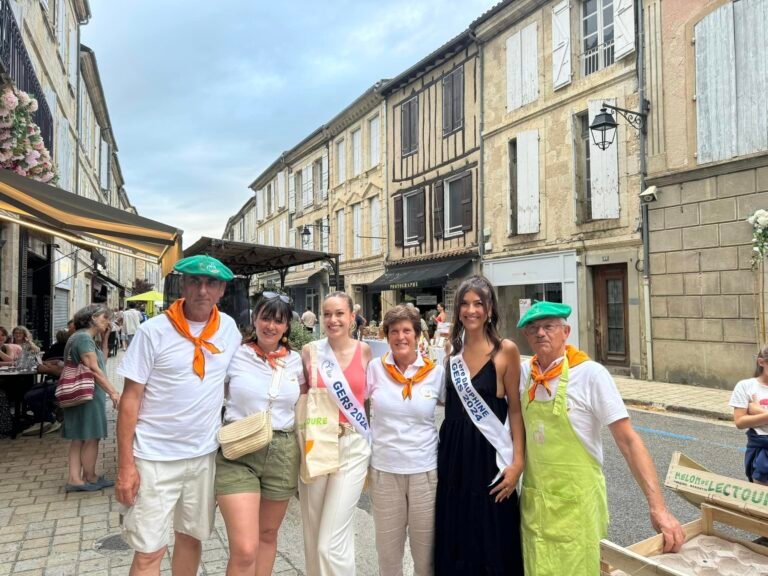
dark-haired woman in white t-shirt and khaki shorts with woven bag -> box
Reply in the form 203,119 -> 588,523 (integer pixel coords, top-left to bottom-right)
215,292 -> 304,575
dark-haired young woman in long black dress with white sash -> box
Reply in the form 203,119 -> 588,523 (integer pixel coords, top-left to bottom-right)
435,276 -> 525,576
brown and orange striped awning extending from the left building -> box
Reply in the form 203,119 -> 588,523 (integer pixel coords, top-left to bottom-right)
0,170 -> 182,274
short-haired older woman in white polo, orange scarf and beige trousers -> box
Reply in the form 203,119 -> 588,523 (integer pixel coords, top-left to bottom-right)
366,305 -> 445,576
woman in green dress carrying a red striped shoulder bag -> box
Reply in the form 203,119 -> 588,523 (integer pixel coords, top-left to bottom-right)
61,304 -> 120,492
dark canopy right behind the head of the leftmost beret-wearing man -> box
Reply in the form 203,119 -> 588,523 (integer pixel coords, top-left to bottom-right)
184,236 -> 338,282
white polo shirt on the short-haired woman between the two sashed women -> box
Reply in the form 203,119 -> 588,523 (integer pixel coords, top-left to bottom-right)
365,354 -> 445,474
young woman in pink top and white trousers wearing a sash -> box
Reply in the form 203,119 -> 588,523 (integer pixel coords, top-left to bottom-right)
299,292 -> 371,576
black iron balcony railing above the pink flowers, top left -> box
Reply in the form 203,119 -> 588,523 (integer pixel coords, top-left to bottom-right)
0,0 -> 54,155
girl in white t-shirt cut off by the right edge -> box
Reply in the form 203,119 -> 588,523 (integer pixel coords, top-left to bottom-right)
730,346 -> 768,485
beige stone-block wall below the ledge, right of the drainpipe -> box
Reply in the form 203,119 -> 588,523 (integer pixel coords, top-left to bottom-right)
649,166 -> 768,388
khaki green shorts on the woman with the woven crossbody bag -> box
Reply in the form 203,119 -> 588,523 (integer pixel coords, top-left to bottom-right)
216,430 -> 300,501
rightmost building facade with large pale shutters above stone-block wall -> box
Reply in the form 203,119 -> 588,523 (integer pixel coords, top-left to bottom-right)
645,0 -> 768,388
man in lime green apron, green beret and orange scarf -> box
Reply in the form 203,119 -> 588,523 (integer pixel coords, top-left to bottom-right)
517,302 -> 685,576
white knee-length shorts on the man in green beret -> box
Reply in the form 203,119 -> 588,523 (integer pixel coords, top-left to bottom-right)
120,452 -> 216,553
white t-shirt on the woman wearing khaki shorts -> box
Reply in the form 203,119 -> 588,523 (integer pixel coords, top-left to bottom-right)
224,344 -> 304,430
